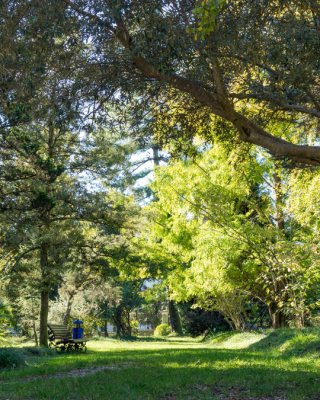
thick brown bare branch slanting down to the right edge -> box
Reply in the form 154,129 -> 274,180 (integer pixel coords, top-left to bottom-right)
63,0 -> 320,166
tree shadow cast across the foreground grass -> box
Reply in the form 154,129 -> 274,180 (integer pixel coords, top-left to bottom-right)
0,348 -> 320,400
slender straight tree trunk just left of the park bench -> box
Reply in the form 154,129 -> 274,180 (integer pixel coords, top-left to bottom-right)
40,243 -> 50,347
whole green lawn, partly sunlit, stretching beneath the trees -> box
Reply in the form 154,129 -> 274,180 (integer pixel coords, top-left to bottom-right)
0,329 -> 320,400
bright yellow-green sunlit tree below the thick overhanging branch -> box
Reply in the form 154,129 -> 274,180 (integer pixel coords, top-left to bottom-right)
147,145 -> 318,329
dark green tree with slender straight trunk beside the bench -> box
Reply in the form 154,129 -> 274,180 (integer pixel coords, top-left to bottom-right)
0,119 -> 132,345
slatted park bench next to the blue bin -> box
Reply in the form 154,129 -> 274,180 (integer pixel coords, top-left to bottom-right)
48,323 -> 89,352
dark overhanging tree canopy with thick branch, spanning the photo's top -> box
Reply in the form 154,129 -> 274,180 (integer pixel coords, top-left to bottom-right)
0,0 -> 320,166
